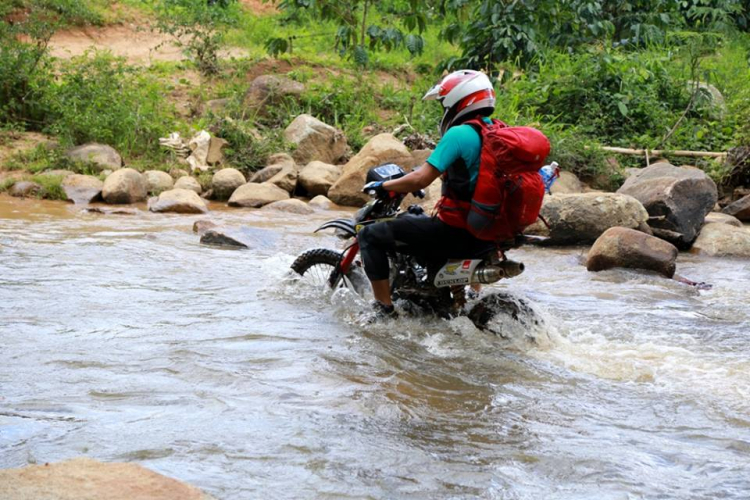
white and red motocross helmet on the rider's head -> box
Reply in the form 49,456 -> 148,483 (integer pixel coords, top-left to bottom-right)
422,69 -> 495,136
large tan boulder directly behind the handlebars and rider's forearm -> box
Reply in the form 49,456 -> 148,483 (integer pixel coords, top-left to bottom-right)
328,134 -> 414,207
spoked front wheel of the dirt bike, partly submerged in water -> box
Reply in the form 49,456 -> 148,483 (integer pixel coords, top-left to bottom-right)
292,248 -> 367,295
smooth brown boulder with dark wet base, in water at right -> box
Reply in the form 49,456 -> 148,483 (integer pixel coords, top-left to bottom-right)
586,227 -> 678,278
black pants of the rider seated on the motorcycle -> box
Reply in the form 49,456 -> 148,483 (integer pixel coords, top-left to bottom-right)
357,215 -> 495,281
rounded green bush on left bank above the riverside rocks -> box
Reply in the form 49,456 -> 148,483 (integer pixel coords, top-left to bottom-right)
42,53 -> 173,154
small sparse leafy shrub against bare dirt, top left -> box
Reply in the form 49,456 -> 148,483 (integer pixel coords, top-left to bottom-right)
155,0 -> 238,75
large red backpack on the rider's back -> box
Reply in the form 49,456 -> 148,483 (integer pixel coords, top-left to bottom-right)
438,118 -> 550,241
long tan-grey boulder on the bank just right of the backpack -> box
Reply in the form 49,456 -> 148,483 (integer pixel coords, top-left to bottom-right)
527,193 -> 648,245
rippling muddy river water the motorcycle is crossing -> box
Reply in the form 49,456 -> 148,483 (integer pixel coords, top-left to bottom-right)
0,197 -> 750,499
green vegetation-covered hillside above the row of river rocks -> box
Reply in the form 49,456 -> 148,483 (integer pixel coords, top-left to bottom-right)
0,0 -> 750,192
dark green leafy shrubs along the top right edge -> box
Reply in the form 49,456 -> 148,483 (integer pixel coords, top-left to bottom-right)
442,0 -> 750,69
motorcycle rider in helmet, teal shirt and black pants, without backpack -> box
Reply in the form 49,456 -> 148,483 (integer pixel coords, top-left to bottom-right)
358,70 -> 495,317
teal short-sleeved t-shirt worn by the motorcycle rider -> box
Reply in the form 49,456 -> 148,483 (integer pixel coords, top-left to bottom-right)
427,118 -> 491,189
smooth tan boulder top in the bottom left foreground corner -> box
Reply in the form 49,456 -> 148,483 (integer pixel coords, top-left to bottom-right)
0,458 -> 212,500
